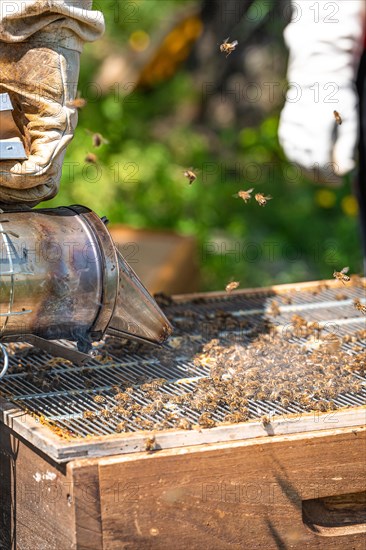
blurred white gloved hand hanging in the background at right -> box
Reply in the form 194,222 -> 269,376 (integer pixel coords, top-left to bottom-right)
278,0 -> 365,184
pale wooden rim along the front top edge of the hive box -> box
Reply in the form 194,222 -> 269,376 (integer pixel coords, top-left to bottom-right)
0,398 -> 366,463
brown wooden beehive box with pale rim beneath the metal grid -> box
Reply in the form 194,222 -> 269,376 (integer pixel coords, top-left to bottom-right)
0,283 -> 366,550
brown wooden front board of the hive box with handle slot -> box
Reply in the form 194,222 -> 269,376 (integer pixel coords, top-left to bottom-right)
99,429 -> 366,550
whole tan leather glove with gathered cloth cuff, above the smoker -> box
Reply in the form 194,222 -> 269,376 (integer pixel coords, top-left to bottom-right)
0,0 -> 104,207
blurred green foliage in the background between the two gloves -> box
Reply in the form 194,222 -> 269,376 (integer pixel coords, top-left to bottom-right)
44,0 -> 361,290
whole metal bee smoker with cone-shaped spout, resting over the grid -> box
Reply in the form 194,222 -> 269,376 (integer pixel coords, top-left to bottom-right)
0,206 -> 172,378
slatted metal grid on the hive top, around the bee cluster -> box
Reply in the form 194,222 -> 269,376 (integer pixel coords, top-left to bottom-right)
0,283 -> 366,438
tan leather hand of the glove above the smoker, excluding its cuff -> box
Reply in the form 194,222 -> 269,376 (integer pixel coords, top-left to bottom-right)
0,42 -> 80,206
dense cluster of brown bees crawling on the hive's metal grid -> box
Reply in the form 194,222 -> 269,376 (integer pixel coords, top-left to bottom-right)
10,280 -> 366,444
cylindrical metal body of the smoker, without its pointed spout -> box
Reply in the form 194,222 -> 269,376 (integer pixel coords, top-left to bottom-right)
0,208 -> 113,341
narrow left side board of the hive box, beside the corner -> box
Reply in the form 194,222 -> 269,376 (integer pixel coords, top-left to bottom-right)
0,424 -> 76,550
